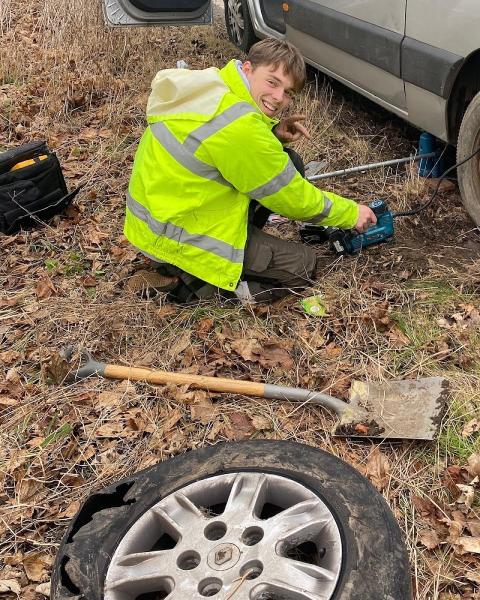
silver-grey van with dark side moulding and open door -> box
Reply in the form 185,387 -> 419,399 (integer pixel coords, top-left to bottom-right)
104,0 -> 480,226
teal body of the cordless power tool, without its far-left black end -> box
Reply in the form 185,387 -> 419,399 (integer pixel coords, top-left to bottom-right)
330,200 -> 394,254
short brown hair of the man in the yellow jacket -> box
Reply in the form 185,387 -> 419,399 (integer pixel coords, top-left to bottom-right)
247,38 -> 305,92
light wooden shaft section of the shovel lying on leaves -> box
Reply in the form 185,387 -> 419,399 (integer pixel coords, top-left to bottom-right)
103,365 -> 265,398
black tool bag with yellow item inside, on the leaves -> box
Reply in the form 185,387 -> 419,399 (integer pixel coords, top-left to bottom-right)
0,142 -> 80,234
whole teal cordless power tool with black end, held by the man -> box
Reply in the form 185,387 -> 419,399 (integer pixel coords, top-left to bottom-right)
300,199 -> 394,255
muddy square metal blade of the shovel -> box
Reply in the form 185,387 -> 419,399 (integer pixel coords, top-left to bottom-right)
335,377 -> 448,440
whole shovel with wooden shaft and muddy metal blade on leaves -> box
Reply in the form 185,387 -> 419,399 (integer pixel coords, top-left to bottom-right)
62,348 -> 447,440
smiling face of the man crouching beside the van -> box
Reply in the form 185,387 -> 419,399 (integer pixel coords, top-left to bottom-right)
242,60 -> 294,117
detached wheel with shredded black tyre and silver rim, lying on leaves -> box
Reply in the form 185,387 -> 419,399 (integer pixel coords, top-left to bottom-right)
52,440 -> 411,600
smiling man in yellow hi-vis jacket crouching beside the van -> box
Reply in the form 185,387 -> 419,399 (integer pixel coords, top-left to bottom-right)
124,39 -> 376,302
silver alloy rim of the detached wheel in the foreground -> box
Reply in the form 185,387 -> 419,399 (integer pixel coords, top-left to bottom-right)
104,472 -> 342,600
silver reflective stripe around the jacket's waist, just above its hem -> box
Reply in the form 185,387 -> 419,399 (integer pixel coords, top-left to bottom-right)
127,193 -> 244,264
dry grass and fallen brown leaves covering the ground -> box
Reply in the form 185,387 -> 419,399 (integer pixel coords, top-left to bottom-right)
0,0 -> 480,600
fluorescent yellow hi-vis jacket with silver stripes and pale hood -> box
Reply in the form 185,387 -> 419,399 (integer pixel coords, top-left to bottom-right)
124,60 -> 358,291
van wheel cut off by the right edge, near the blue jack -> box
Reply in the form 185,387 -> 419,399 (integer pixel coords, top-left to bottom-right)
457,93 -> 480,226
